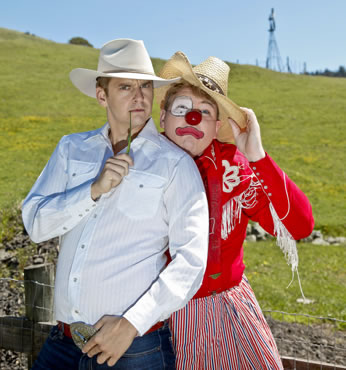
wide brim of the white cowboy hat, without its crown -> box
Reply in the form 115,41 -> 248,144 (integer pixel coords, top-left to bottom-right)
70,68 -> 180,98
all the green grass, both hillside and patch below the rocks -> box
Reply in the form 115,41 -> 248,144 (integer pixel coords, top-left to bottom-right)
0,28 -> 346,330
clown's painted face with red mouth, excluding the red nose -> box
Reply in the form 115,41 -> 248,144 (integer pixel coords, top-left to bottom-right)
160,87 -> 221,157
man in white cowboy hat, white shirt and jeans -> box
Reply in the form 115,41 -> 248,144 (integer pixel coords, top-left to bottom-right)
22,39 -> 208,370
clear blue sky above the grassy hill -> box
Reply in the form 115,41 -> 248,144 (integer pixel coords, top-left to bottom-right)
0,0 -> 346,73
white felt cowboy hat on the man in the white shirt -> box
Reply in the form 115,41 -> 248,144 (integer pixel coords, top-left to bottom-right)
70,39 -> 180,98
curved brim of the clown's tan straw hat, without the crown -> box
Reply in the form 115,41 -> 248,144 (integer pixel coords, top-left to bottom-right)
155,52 -> 247,143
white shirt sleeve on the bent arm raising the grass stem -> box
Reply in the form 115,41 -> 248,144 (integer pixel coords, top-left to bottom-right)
22,137 -> 96,243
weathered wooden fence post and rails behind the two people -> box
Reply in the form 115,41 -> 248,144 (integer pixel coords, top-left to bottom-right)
0,264 -> 346,370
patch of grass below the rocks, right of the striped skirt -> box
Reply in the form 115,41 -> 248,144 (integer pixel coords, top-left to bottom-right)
244,241 -> 346,329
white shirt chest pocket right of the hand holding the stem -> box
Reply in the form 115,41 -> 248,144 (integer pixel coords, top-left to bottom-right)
118,170 -> 166,220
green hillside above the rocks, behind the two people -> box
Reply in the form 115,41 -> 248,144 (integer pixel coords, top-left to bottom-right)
0,28 -> 346,234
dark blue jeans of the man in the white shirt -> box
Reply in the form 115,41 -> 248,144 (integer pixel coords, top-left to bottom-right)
32,322 -> 175,370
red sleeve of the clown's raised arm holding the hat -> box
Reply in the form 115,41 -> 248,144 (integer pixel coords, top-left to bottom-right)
245,154 -> 314,240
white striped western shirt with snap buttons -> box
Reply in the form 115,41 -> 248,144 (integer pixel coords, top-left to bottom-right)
22,120 -> 209,335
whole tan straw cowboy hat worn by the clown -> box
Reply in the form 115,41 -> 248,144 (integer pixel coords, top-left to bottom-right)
155,51 -> 247,142
